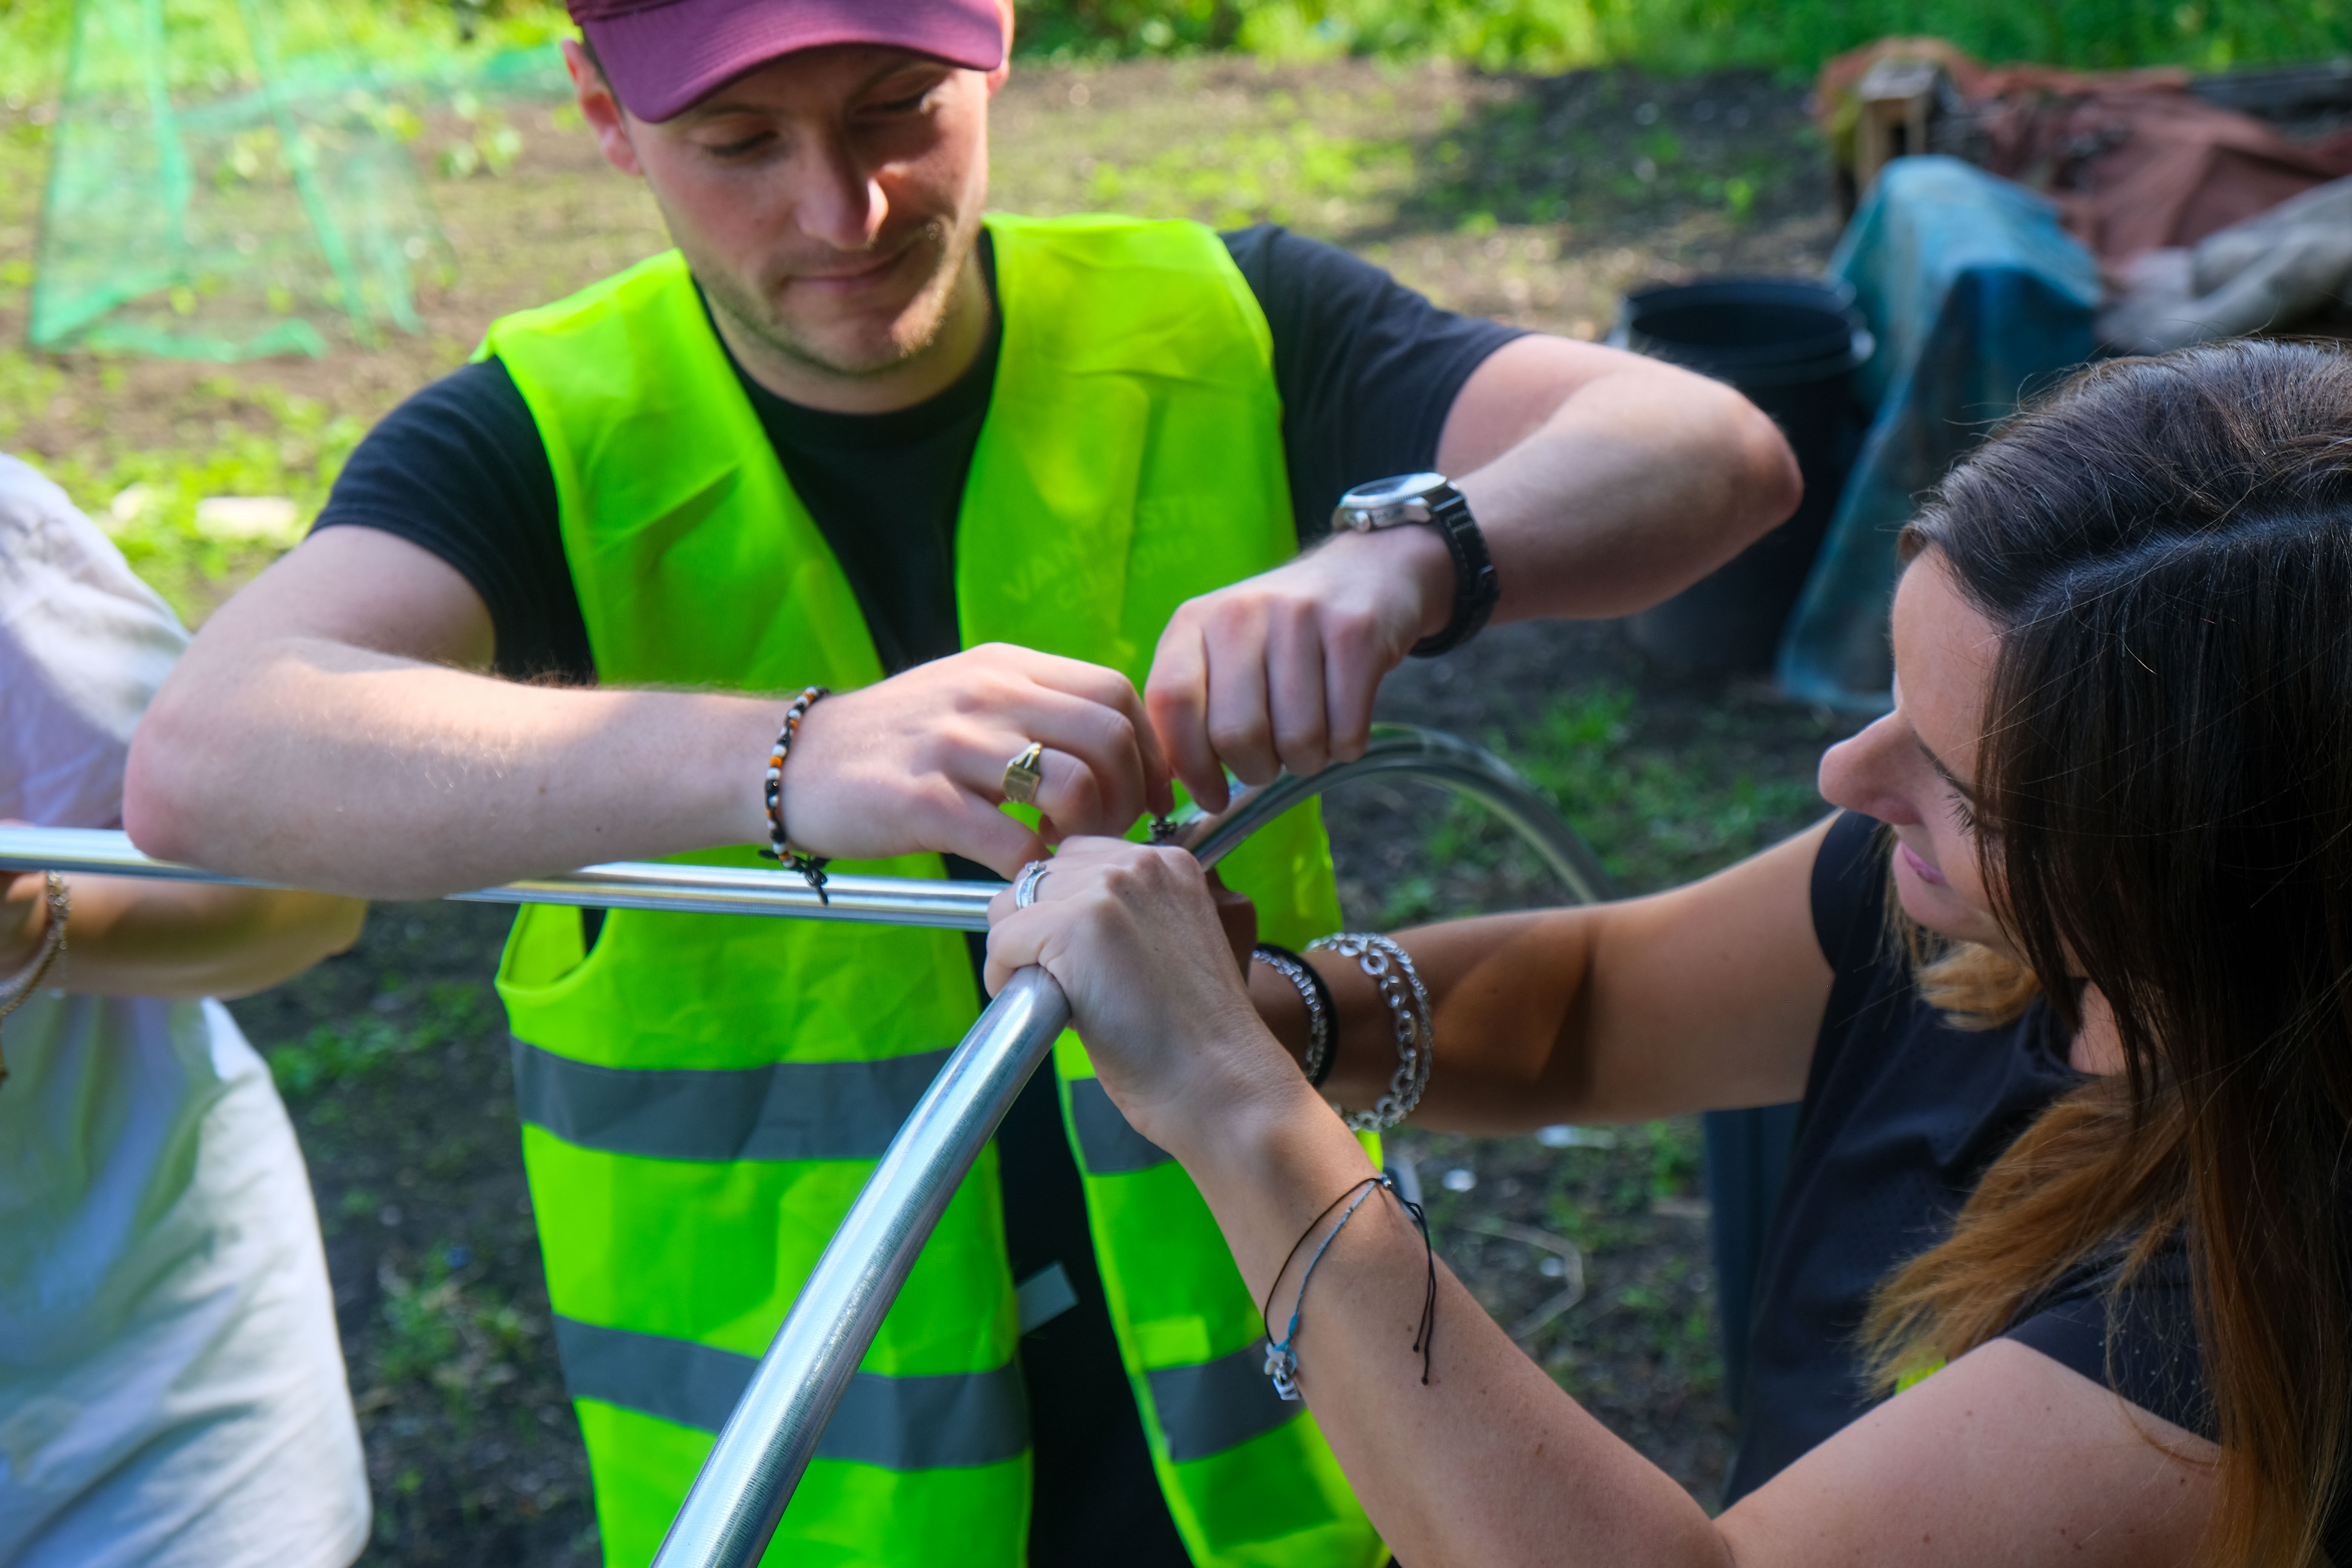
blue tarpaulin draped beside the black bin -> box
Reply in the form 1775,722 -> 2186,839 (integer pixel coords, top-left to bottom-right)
1778,158 -> 2100,710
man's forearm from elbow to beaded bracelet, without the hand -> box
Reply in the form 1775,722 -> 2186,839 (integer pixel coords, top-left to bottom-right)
125,637 -> 783,898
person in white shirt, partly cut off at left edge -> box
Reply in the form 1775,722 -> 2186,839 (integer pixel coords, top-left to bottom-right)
0,456 -> 369,1568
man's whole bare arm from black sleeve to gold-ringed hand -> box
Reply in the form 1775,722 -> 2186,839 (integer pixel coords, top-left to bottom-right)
125,529 -> 1171,898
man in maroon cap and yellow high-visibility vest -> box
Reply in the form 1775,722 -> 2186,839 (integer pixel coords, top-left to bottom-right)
127,0 -> 1797,1568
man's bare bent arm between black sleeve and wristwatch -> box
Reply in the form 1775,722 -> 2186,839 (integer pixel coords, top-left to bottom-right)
1439,338 -> 1802,621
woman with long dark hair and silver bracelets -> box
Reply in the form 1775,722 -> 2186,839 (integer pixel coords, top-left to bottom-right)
990,343 -> 2352,1568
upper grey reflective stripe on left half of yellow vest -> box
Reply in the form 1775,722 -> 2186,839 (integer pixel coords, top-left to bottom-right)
515,1039 -> 955,1161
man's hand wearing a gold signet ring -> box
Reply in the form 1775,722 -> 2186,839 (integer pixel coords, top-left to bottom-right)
778,642 -> 1174,877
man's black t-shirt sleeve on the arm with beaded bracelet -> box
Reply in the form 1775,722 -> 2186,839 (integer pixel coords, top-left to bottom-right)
313,360 -> 595,684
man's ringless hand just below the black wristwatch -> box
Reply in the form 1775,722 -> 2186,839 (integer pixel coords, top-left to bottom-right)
1143,527 -> 1453,811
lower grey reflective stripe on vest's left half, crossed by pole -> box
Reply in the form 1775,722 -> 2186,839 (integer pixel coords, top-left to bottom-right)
555,1312 -> 1028,1469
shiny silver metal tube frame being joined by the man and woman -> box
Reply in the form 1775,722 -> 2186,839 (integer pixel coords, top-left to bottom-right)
0,724 -> 1614,1568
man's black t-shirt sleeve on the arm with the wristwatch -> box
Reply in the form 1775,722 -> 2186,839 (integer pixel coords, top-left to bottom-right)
1225,224 -> 1527,543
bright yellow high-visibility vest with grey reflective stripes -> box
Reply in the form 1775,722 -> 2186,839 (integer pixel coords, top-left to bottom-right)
482,219 -> 1385,1568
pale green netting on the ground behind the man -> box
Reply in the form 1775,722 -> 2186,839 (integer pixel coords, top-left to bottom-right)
26,0 -> 562,360
